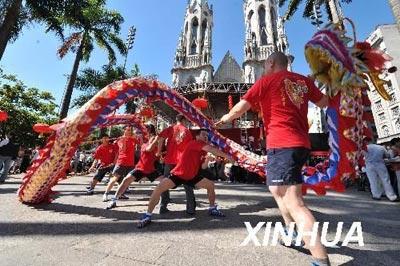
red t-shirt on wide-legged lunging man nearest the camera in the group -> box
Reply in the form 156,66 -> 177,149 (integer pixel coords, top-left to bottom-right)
171,140 -> 207,180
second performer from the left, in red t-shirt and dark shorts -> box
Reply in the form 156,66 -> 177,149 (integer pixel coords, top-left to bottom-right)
103,126 -> 138,201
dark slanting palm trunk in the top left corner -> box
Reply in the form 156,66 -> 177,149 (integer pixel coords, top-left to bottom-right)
0,0 -> 22,60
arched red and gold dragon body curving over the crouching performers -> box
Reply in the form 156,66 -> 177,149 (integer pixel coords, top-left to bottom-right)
18,78 -> 265,204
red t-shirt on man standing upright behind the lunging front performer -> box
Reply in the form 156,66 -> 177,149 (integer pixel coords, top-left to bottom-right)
159,124 -> 192,164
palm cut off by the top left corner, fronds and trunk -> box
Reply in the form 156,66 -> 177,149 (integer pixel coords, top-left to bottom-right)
0,0 -> 86,60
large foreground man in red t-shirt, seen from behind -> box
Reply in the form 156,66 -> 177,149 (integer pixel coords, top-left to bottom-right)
217,52 -> 329,264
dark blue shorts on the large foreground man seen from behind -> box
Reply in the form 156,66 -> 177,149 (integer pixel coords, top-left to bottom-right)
266,147 -> 310,186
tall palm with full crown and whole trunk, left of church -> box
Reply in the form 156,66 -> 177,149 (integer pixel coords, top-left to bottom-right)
58,0 -> 127,119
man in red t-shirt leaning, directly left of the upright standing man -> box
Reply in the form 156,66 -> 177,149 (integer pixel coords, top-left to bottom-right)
106,124 -> 162,210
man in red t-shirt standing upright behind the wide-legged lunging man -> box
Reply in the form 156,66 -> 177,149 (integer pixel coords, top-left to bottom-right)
157,114 -> 196,215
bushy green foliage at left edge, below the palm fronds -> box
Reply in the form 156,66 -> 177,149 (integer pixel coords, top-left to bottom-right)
0,69 -> 57,147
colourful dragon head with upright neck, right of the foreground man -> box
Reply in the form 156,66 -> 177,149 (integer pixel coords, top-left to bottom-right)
303,25 -> 391,193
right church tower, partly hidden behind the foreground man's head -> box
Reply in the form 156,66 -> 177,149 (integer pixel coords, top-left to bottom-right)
243,0 -> 289,83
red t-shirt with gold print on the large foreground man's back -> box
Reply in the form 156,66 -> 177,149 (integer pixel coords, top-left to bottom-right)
243,70 -> 323,149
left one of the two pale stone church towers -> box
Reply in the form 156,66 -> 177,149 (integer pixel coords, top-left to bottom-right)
171,0 -> 214,88
